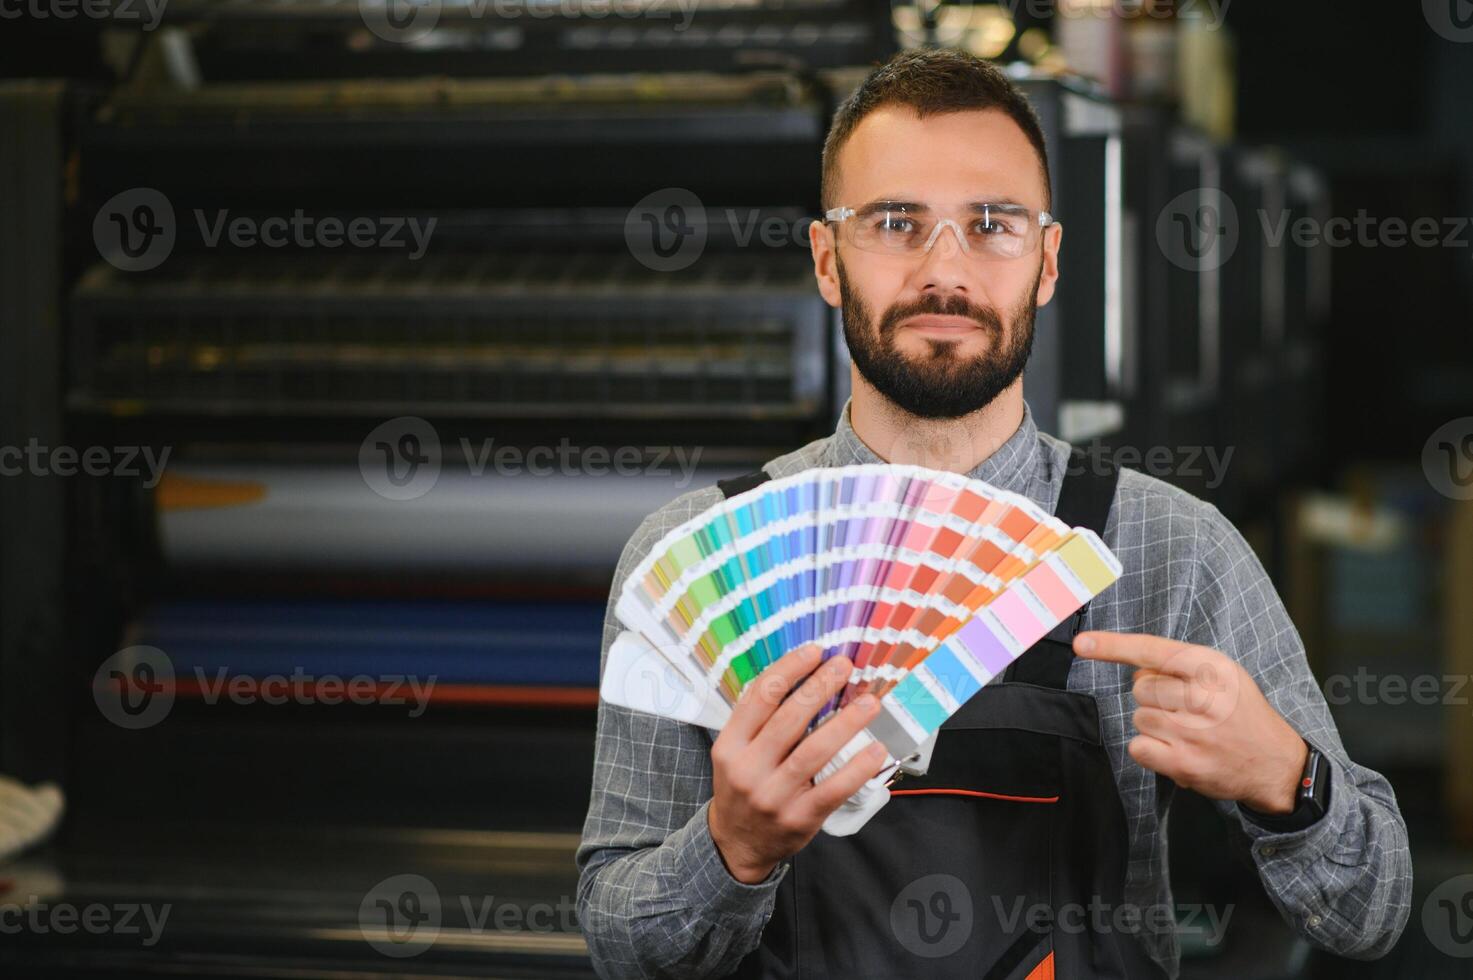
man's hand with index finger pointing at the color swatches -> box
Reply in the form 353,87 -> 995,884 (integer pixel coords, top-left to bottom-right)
1074,631 -> 1309,815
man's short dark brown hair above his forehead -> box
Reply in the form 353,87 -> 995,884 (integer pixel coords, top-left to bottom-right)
820,49 -> 1053,211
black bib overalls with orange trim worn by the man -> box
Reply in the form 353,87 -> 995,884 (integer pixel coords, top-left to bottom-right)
722,454 -> 1174,980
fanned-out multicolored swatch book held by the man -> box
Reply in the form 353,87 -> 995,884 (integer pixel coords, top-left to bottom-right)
601,464 -> 1121,834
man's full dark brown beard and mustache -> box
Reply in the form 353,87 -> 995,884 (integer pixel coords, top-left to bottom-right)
838,253 -> 1043,419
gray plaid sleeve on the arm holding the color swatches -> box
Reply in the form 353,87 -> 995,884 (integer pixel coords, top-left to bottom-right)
576,506 -> 788,980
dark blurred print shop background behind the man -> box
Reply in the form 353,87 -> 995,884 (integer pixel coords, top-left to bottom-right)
0,0 -> 1473,980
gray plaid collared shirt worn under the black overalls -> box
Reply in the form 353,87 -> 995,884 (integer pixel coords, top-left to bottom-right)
577,405 -> 1411,977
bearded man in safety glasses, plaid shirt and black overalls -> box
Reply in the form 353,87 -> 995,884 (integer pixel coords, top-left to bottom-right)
577,52 -> 1411,980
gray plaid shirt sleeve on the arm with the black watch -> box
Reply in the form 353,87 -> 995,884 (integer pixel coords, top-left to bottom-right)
1183,504 -> 1411,959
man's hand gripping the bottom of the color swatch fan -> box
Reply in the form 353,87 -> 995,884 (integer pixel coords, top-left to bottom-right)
707,645 -> 887,884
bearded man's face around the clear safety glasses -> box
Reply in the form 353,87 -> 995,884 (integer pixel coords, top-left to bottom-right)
810,106 -> 1061,419
